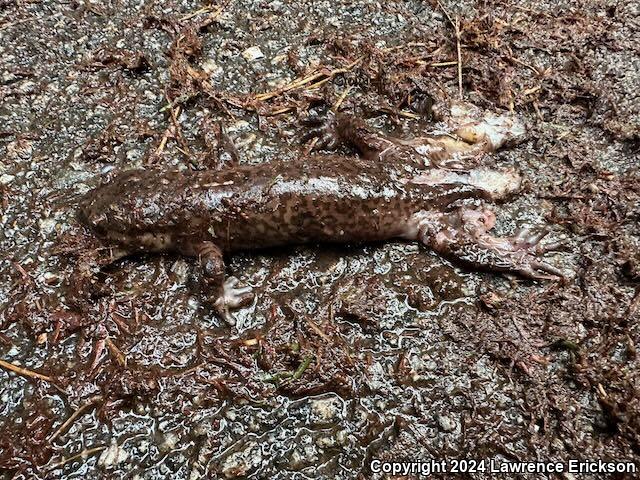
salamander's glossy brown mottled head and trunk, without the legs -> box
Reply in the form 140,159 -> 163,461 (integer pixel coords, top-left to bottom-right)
82,156 -> 490,254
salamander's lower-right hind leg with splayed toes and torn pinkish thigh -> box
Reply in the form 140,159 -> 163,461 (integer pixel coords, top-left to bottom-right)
414,208 -> 565,280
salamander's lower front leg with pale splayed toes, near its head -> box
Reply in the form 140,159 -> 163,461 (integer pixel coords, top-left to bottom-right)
196,242 -> 253,325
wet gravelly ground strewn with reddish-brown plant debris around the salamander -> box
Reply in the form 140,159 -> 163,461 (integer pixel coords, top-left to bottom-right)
0,0 -> 640,479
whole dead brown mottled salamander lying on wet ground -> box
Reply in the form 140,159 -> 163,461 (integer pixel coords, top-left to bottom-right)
79,105 -> 560,318
